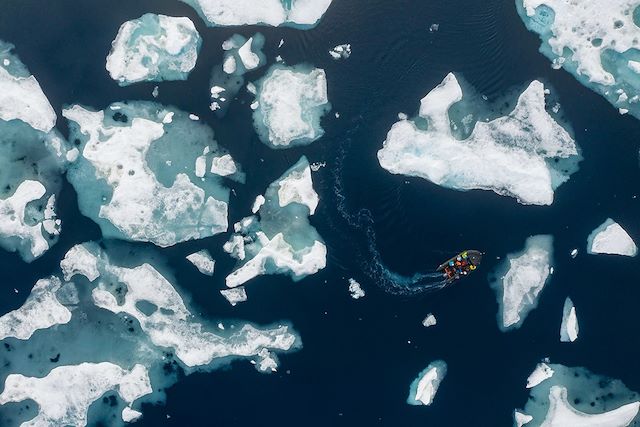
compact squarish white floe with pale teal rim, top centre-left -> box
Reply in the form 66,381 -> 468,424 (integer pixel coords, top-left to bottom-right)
253,64 -> 331,148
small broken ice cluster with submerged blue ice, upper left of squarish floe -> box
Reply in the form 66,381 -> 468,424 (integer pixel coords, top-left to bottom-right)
209,33 -> 267,116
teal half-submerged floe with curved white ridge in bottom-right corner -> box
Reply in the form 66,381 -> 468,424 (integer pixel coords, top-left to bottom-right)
514,363 -> 640,427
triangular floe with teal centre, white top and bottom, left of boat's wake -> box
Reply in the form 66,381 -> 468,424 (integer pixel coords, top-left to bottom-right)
224,156 -> 327,288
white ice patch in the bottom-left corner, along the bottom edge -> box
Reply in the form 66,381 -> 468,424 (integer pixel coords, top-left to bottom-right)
0,362 -> 152,427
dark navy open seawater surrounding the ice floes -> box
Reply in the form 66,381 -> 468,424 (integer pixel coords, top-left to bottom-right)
0,0 -> 640,427
